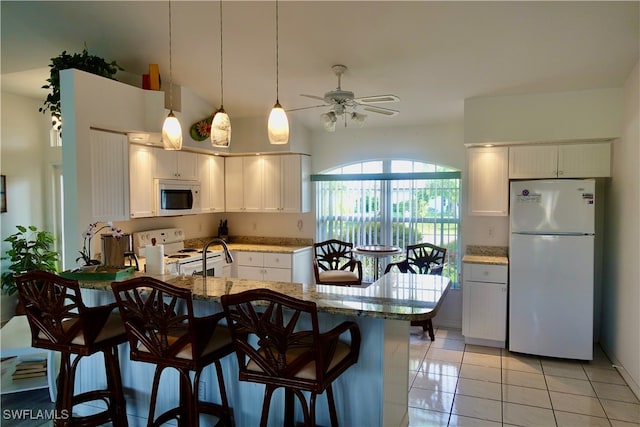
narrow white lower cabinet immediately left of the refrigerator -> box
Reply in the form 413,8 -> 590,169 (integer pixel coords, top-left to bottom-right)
462,263 -> 509,348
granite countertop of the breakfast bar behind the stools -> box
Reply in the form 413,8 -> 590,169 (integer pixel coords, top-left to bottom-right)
80,272 -> 450,320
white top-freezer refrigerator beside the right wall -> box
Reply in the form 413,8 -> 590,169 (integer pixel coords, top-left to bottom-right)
508,179 -> 597,360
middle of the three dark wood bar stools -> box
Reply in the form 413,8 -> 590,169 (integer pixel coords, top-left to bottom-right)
111,277 -> 233,427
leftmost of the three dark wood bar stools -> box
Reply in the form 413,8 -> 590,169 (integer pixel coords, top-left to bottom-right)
16,271 -> 128,427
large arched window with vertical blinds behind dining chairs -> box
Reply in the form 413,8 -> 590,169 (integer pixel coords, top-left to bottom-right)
311,160 -> 460,283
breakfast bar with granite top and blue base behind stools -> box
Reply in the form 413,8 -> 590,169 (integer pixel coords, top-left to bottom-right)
77,273 -> 449,427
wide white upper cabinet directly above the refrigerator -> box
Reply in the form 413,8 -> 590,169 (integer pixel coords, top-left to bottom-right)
509,142 -> 611,179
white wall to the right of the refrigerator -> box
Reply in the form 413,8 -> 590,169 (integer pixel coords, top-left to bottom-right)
601,62 -> 640,396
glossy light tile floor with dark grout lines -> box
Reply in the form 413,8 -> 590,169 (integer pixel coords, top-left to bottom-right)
409,328 -> 640,427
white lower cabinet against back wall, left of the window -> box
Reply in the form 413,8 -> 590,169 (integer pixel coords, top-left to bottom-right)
232,247 -> 311,283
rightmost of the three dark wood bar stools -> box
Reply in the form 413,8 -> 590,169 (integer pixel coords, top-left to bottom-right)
221,289 -> 360,427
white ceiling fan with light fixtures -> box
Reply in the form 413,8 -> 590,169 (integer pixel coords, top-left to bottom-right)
289,64 -> 400,132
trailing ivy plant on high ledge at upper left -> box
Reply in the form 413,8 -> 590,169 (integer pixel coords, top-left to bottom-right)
38,46 -> 124,130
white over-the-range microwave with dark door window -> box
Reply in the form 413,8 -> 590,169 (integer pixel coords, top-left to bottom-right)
154,179 -> 201,216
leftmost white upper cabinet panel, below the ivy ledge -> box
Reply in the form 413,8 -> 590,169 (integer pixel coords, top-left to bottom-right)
89,130 -> 129,221
